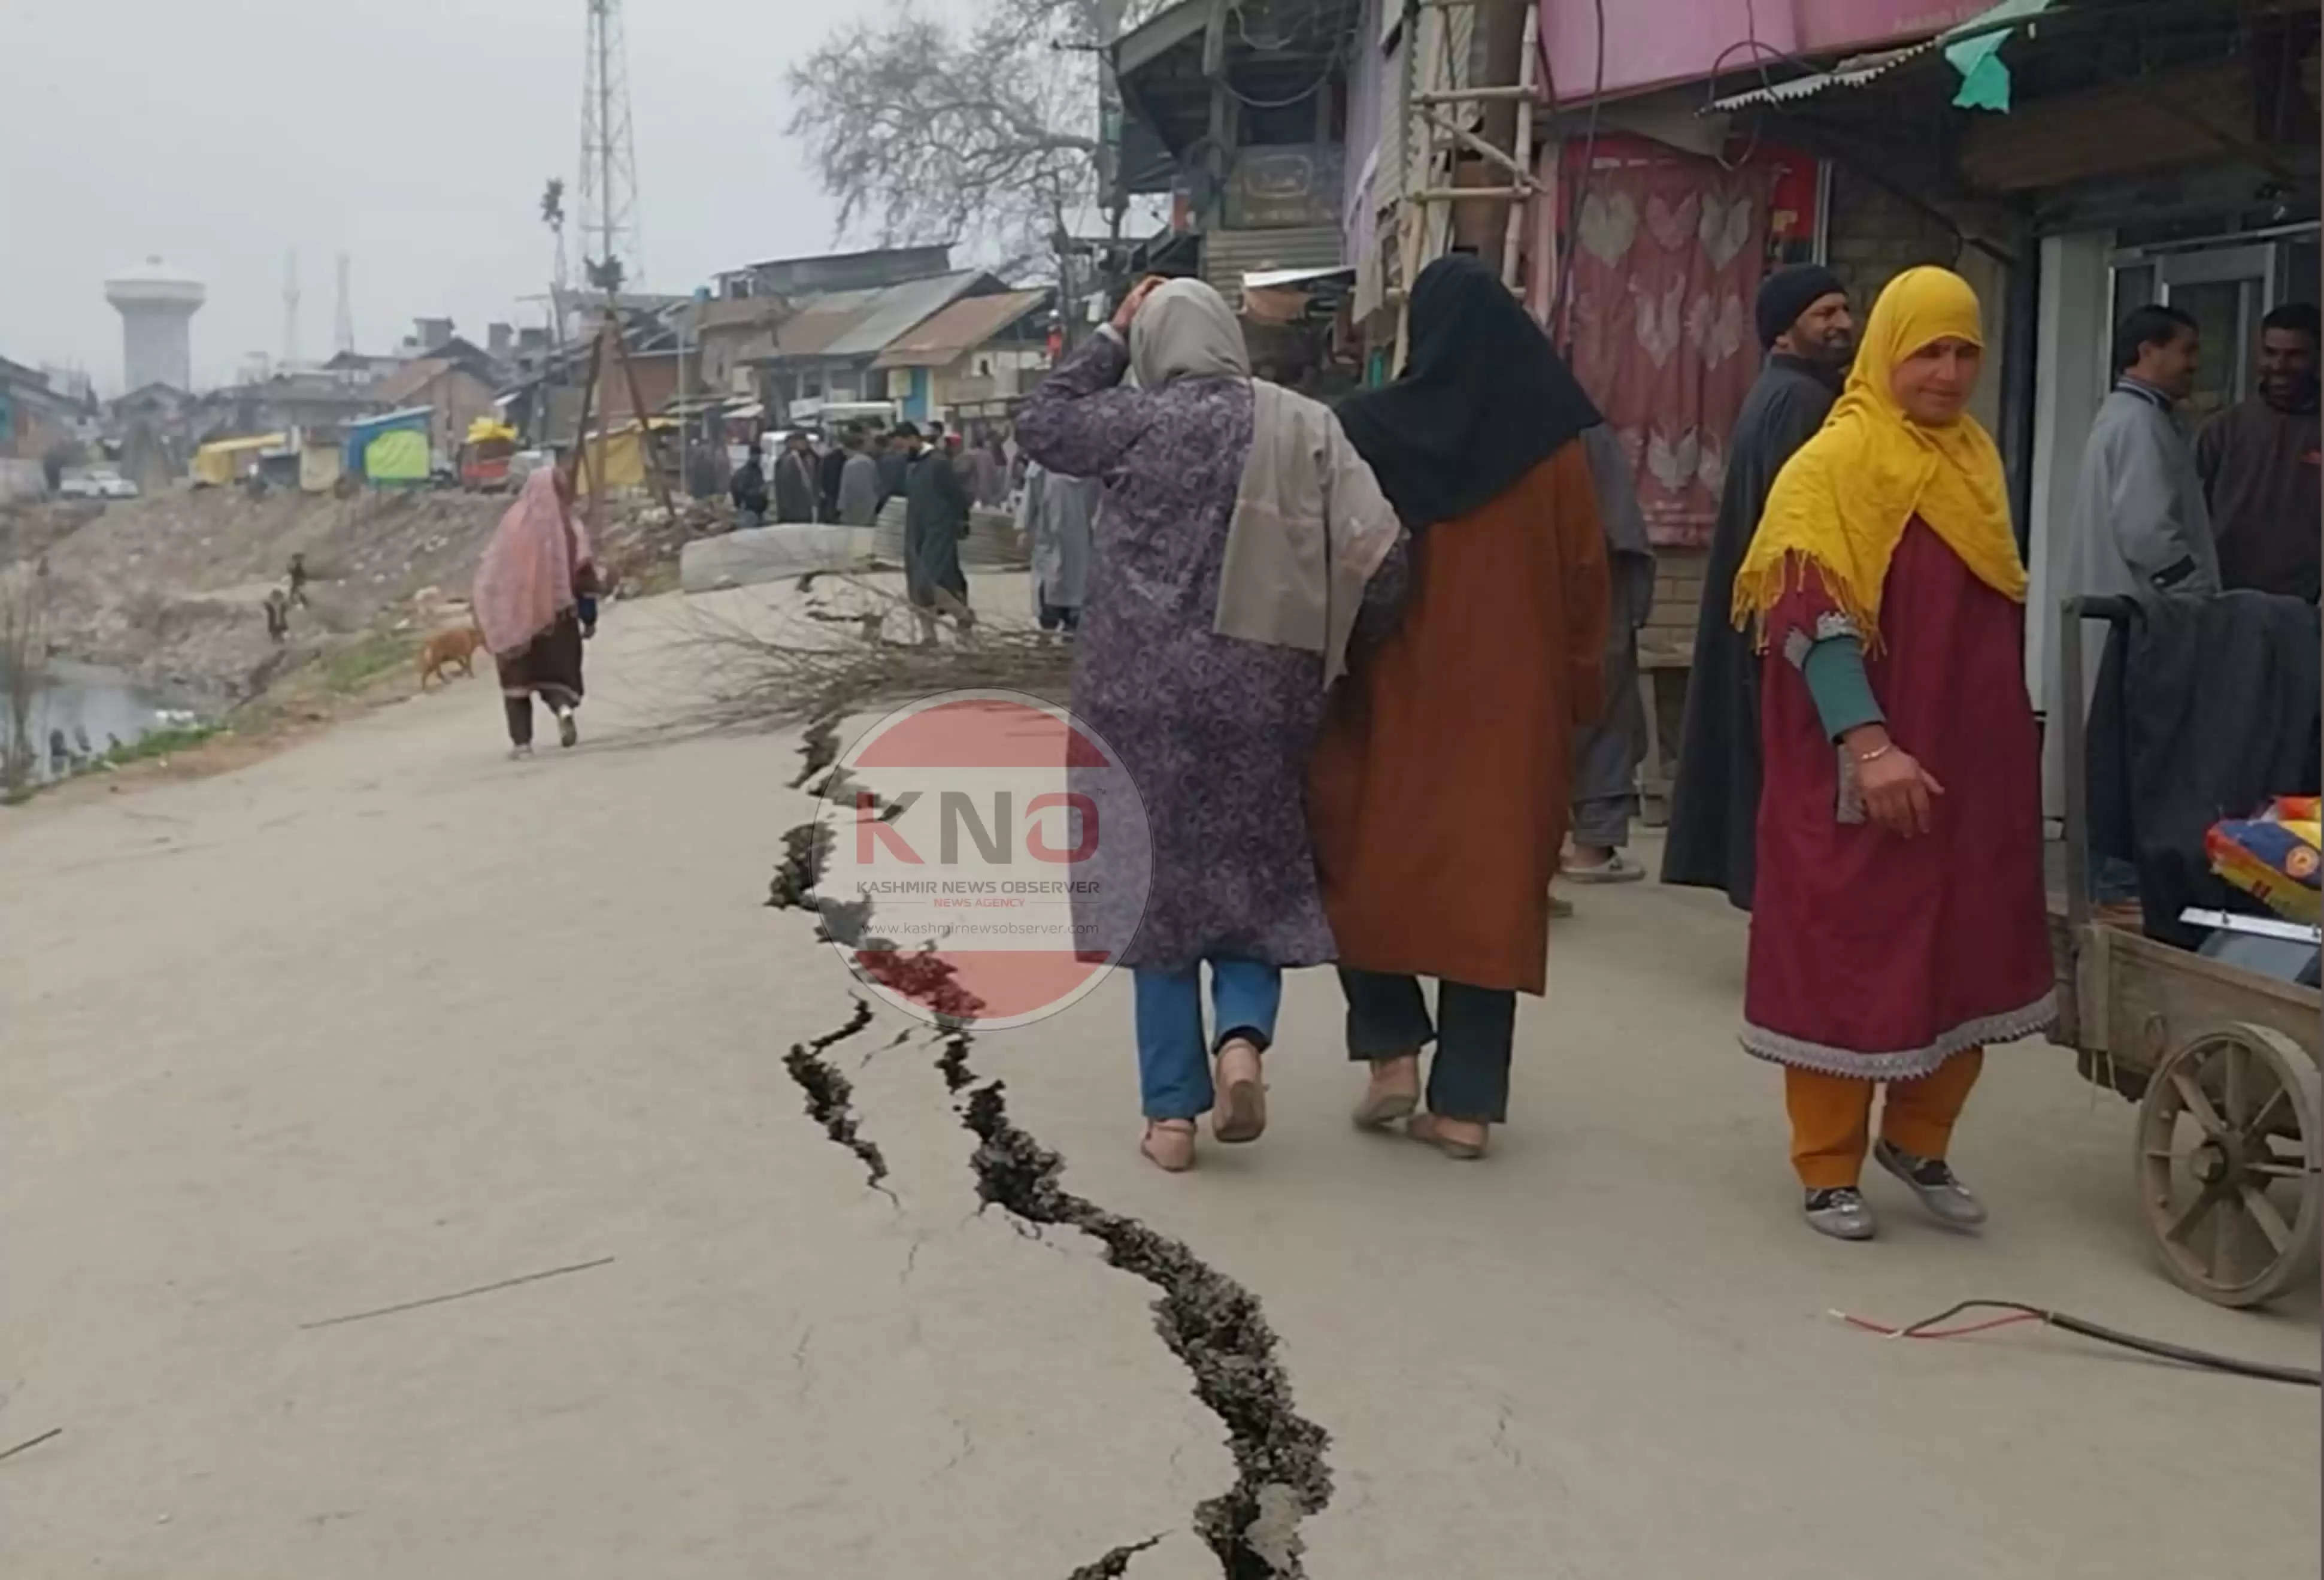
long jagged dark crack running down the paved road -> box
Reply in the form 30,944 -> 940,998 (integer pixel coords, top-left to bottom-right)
767,713 -> 1332,1580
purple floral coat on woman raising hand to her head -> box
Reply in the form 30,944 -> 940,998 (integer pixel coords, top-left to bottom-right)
1016,332 -> 1404,969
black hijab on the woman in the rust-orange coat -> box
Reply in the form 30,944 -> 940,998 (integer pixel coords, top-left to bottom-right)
1338,253 -> 1604,532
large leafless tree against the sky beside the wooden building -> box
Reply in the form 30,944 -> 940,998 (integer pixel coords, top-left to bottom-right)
790,0 -> 1153,272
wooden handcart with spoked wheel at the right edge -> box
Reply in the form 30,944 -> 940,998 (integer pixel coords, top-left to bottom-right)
2050,597 -> 2324,1306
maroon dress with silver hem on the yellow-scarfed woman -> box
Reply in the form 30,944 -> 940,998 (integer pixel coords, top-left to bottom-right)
1743,516 -> 2057,1080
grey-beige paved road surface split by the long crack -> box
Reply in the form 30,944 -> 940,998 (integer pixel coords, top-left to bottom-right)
0,583 -> 2319,1580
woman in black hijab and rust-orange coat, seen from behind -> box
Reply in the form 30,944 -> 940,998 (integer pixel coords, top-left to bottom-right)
1308,258 -> 1606,1157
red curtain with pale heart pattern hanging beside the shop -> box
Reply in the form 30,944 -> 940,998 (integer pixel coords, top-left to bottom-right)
1562,144 -> 1775,549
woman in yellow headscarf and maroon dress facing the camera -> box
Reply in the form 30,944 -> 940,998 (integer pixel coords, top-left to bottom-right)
1734,267 -> 2055,1239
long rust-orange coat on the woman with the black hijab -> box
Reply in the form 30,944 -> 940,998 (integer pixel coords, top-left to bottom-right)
1308,441 -> 1608,994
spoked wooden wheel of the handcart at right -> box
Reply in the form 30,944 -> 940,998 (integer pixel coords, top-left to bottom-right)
2138,1022 -> 2324,1306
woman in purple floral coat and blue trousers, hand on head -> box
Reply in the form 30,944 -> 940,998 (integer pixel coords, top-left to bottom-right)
1018,281 -> 1404,1173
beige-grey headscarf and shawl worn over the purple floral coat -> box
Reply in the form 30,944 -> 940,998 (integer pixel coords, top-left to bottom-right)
1129,279 -> 1401,685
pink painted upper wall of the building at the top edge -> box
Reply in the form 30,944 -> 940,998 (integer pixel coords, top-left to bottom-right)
1541,0 -> 1992,105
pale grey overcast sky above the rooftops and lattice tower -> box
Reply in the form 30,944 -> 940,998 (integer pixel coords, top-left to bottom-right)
0,0 -> 878,393
